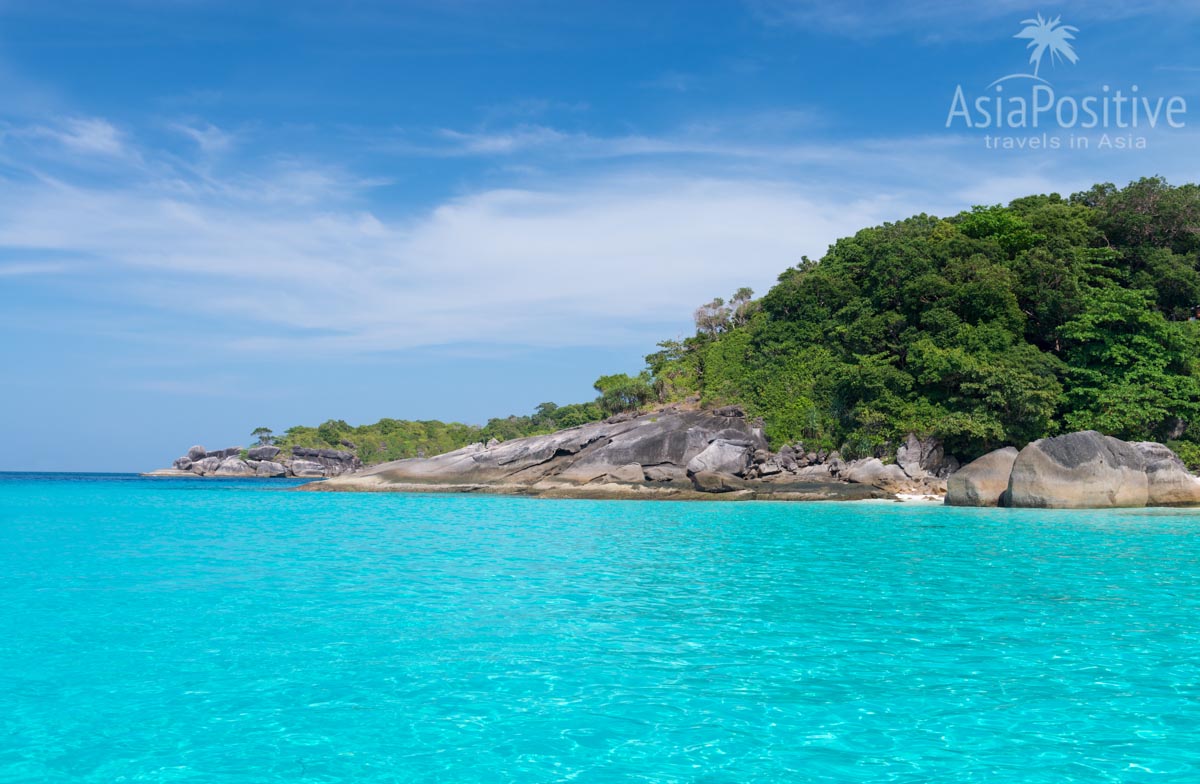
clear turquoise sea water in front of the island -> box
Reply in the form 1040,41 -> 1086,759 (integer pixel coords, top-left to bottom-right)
0,475 -> 1200,784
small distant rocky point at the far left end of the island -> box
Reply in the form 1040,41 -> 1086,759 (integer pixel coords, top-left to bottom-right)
142,445 -> 362,479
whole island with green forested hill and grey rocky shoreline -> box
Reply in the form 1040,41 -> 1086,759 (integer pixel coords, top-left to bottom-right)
155,178 -> 1200,507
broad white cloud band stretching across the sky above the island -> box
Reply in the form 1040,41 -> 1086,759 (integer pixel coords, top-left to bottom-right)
0,108 -> 1196,352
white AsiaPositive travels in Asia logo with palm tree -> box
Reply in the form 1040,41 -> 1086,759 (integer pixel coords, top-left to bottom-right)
946,13 -> 1188,150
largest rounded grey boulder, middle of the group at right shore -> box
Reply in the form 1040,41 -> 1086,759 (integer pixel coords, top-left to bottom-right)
1007,430 -> 1150,509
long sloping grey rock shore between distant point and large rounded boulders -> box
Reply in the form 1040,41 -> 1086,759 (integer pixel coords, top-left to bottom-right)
295,407 -> 958,501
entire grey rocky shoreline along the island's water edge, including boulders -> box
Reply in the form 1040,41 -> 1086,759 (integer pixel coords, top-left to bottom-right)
144,406 -> 1200,509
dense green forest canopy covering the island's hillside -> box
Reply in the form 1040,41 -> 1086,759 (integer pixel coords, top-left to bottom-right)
272,178 -> 1200,462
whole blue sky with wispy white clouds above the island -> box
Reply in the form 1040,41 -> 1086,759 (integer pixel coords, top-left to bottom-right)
0,0 -> 1200,471
